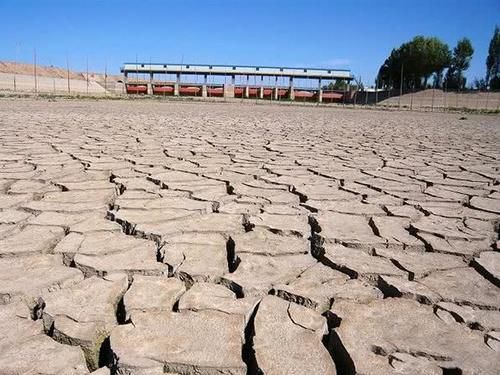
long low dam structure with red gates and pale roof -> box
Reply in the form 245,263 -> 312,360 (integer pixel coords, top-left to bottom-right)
121,62 -> 353,103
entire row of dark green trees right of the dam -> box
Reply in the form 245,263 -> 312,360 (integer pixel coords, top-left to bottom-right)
377,27 -> 500,90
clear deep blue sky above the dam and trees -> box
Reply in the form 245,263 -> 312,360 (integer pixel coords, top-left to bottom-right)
0,0 -> 500,84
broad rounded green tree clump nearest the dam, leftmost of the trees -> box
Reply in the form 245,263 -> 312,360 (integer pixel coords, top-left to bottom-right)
378,36 -> 451,89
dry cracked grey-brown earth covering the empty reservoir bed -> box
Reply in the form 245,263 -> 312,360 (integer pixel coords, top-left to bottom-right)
0,99 -> 500,375
